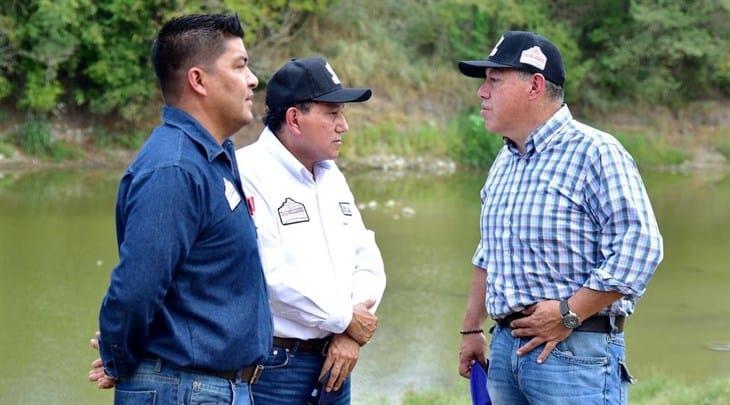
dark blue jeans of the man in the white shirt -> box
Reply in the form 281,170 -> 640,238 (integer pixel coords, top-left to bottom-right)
251,340 -> 350,405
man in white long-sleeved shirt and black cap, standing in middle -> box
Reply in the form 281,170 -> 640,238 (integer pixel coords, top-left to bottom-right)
236,58 -> 385,405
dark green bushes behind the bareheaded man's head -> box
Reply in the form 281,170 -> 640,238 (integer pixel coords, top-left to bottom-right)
0,0 -> 328,121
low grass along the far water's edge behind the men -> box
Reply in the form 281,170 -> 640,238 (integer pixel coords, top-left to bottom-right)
0,109 -> 708,168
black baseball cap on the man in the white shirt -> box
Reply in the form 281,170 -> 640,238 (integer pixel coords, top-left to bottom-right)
266,58 -> 373,109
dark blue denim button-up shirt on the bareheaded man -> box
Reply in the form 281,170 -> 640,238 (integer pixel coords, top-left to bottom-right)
99,107 -> 272,378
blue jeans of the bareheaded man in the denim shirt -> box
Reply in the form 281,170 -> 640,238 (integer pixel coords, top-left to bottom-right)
114,360 -> 251,405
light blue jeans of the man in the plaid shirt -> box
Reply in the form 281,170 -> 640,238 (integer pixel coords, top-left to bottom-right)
487,325 -> 633,405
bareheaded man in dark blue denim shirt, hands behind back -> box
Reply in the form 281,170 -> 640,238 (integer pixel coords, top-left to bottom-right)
97,15 -> 272,404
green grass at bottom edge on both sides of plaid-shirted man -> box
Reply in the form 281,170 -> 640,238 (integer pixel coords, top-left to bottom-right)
373,376 -> 730,405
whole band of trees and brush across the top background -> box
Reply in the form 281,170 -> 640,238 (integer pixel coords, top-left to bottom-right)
0,0 -> 730,144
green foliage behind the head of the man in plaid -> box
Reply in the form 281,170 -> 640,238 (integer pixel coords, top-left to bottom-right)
372,0 -> 730,107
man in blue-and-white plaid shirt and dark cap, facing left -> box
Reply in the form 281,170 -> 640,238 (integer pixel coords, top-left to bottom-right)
459,31 -> 663,404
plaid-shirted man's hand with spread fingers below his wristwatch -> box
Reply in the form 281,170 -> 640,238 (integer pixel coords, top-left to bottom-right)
510,300 -> 572,363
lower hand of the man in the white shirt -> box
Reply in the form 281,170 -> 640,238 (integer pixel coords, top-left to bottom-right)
317,333 -> 360,392
